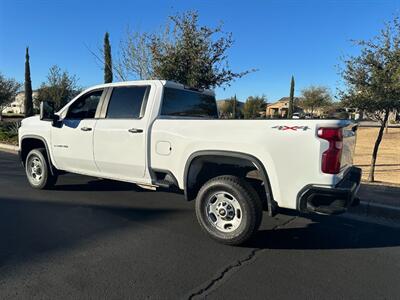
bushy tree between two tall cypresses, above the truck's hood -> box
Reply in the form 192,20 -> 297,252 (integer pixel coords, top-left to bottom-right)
37,65 -> 80,109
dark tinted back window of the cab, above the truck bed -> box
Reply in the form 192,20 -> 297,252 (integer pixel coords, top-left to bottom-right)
161,88 -> 218,118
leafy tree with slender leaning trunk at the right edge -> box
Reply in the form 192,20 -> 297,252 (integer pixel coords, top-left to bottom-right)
341,17 -> 400,181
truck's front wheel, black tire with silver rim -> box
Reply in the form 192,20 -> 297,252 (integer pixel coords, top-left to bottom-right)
25,148 -> 57,190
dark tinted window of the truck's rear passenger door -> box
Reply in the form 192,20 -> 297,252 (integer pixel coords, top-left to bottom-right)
106,86 -> 148,119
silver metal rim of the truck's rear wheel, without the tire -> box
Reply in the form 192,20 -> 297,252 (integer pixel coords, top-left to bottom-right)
206,191 -> 243,232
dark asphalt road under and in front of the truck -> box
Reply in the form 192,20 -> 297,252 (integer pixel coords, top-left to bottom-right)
0,152 -> 400,299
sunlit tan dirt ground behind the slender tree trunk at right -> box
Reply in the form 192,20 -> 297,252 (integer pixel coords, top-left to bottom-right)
354,127 -> 400,184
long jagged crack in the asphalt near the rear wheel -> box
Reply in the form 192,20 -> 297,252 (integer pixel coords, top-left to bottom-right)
187,216 -> 297,300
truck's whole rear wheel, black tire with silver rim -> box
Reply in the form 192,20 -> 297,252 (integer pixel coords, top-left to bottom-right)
196,175 -> 263,245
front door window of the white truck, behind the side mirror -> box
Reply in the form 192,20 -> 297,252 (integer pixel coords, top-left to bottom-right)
66,90 -> 103,120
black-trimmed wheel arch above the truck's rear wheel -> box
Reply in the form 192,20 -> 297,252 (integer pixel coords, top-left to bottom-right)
183,150 -> 277,216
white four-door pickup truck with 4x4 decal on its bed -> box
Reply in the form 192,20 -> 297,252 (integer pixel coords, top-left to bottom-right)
19,80 -> 361,245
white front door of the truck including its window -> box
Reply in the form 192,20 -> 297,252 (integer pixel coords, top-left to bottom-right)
51,89 -> 104,175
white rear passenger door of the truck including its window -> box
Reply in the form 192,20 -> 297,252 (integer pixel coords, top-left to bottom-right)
93,85 -> 150,181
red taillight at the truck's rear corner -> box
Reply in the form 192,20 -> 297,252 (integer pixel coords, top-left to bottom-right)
318,128 -> 343,174
